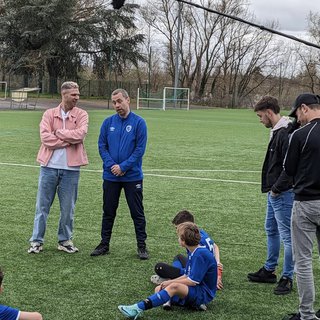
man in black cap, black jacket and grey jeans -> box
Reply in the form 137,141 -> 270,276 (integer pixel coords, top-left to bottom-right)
284,93 -> 320,320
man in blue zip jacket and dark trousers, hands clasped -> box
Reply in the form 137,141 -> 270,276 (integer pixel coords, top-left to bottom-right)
91,89 -> 148,260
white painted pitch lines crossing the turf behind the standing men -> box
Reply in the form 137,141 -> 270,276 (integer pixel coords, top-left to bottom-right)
0,162 -> 260,185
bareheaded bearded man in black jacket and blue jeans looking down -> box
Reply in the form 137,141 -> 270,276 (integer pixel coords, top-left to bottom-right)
248,96 -> 294,295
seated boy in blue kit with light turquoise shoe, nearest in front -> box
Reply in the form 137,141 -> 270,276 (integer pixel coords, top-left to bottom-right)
118,222 -> 217,319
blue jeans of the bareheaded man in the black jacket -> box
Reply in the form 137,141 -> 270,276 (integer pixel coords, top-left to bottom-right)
264,190 -> 294,279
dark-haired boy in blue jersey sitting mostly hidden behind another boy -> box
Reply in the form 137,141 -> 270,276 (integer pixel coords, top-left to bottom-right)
151,210 -> 223,292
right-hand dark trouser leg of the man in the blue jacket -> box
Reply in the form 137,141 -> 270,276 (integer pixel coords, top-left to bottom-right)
124,180 -> 147,247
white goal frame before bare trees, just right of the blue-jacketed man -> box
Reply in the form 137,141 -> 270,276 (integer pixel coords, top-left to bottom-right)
137,87 -> 190,111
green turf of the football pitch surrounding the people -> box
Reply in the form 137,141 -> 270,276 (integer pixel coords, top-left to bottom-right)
0,109 -> 319,320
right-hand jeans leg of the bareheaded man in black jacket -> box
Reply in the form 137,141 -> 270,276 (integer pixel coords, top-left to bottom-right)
269,190 -> 294,279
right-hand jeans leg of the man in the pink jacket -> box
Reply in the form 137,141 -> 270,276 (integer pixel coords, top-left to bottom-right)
57,169 -> 80,242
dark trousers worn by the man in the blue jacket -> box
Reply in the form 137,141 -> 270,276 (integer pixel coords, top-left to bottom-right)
101,180 -> 147,247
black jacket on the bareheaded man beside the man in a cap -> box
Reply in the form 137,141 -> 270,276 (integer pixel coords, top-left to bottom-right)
261,123 -> 293,193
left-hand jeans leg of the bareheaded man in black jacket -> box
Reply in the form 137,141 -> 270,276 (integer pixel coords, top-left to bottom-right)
264,193 -> 280,271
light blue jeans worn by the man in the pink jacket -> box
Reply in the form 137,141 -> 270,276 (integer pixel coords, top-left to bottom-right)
30,167 -> 80,243
